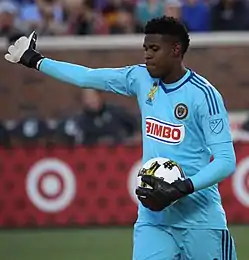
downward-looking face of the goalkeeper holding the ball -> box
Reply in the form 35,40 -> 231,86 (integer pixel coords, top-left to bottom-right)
143,34 -> 175,78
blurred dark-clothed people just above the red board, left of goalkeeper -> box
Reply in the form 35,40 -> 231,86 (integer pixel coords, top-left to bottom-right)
0,89 -> 141,148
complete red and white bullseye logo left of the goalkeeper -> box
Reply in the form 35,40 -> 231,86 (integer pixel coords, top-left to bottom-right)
26,158 -> 76,213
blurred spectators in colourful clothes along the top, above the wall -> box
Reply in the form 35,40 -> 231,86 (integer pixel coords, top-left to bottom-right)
0,0 -> 249,38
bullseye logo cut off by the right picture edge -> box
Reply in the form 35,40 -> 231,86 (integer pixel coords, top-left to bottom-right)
232,157 -> 249,207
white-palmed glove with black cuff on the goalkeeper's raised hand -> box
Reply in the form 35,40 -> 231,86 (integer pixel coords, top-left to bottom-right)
4,32 -> 44,69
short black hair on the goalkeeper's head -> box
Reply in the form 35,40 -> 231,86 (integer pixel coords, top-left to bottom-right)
144,16 -> 190,55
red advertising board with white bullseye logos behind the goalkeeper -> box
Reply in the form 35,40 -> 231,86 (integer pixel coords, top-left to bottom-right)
0,143 -> 249,227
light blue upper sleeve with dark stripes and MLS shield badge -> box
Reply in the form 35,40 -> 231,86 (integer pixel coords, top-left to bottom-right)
198,86 -> 232,146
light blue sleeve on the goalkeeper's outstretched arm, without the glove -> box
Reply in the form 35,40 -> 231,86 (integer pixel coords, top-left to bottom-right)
39,58 -> 137,96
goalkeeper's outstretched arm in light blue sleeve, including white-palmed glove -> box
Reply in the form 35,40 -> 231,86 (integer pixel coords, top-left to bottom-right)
5,32 -> 137,96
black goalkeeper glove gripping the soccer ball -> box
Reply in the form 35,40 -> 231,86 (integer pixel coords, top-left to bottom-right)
136,175 -> 194,211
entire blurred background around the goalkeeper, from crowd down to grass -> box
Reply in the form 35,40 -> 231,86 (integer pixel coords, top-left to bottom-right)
0,0 -> 249,260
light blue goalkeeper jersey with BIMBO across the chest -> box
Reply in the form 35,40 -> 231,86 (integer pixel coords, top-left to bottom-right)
40,59 -> 232,229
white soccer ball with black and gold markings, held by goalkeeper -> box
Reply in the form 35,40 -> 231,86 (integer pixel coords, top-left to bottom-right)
137,157 -> 186,189
